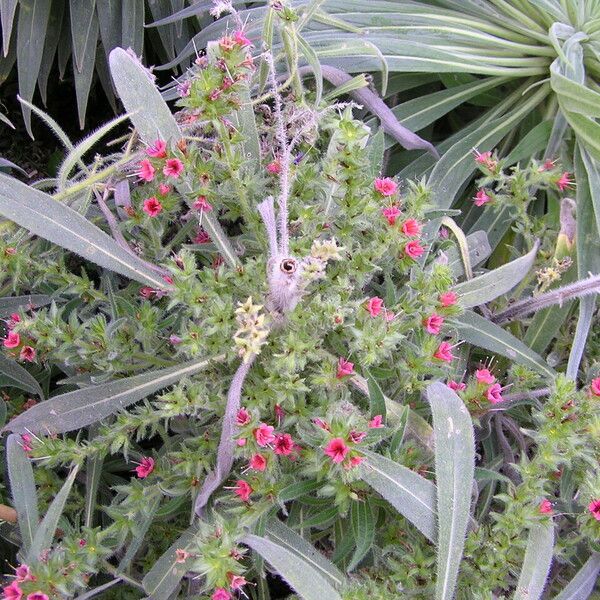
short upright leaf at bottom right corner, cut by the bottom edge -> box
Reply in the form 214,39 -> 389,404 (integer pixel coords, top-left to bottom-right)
513,521 -> 554,600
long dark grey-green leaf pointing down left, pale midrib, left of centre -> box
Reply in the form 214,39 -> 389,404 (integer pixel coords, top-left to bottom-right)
5,360 -> 219,433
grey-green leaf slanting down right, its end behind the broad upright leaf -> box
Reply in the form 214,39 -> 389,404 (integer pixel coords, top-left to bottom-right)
360,450 -> 437,542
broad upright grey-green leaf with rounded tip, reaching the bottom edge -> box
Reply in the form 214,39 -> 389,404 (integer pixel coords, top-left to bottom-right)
427,382 -> 475,600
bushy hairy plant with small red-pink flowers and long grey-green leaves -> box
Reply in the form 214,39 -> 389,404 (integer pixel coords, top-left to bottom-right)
0,2 -> 600,600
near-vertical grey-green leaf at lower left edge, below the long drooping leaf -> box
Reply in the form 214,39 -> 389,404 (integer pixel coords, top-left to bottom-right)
6,434 -> 40,551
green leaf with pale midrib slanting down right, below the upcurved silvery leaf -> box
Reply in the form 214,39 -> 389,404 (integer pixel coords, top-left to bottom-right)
449,310 -> 556,379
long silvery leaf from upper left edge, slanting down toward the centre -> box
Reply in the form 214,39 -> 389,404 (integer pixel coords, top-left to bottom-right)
0,174 -> 166,289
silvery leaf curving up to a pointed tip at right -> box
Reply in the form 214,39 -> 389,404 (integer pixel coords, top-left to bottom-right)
454,243 -> 539,308
